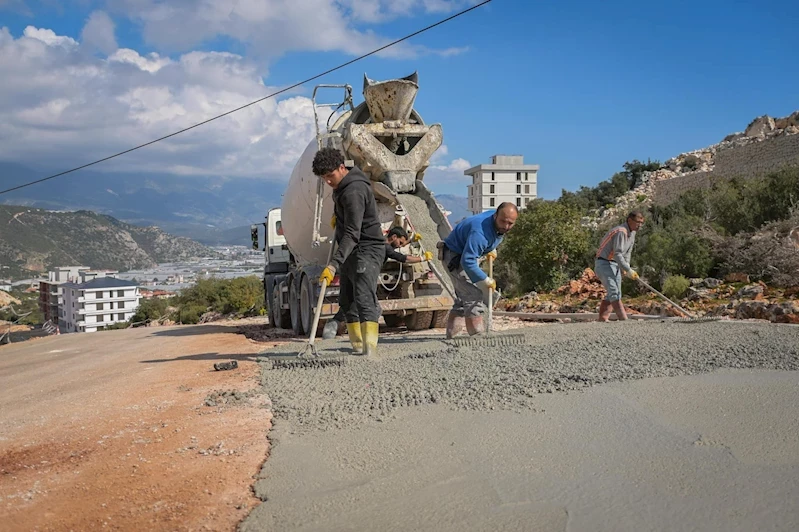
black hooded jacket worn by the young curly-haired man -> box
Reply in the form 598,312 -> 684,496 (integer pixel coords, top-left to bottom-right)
330,167 -> 386,270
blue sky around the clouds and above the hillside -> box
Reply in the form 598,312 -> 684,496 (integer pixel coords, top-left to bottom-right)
0,0 -> 799,198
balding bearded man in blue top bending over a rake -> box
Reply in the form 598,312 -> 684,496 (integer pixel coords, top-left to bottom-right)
439,202 -> 519,338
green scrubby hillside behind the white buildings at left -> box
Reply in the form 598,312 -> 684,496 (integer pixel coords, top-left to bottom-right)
0,205 -> 216,278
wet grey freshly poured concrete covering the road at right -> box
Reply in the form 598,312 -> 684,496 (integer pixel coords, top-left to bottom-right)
241,323 -> 799,531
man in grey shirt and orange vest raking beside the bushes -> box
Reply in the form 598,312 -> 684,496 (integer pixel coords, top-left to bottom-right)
594,211 -> 644,321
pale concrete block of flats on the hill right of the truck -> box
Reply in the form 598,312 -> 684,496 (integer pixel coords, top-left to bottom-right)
463,155 -> 540,214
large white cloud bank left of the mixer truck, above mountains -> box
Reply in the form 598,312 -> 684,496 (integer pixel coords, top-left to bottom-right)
0,27 -> 324,178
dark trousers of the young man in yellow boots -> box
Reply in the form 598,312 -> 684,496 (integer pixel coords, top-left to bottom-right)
337,245 -> 386,323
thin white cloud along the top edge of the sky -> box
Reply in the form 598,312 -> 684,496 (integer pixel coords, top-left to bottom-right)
107,0 -> 475,59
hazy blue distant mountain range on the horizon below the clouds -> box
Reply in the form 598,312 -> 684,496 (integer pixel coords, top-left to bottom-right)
0,162 -> 470,246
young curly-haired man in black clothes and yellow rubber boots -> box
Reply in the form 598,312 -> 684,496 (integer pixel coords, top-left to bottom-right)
313,148 -> 386,356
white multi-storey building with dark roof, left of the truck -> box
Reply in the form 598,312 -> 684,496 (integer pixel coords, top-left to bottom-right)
61,277 -> 141,332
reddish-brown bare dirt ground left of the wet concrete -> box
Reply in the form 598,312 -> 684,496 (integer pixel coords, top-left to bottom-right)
0,323 -> 288,530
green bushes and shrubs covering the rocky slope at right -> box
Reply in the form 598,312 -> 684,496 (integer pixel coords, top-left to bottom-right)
497,161 -> 799,296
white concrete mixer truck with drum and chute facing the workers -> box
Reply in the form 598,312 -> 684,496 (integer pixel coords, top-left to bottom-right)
250,73 -> 460,335
